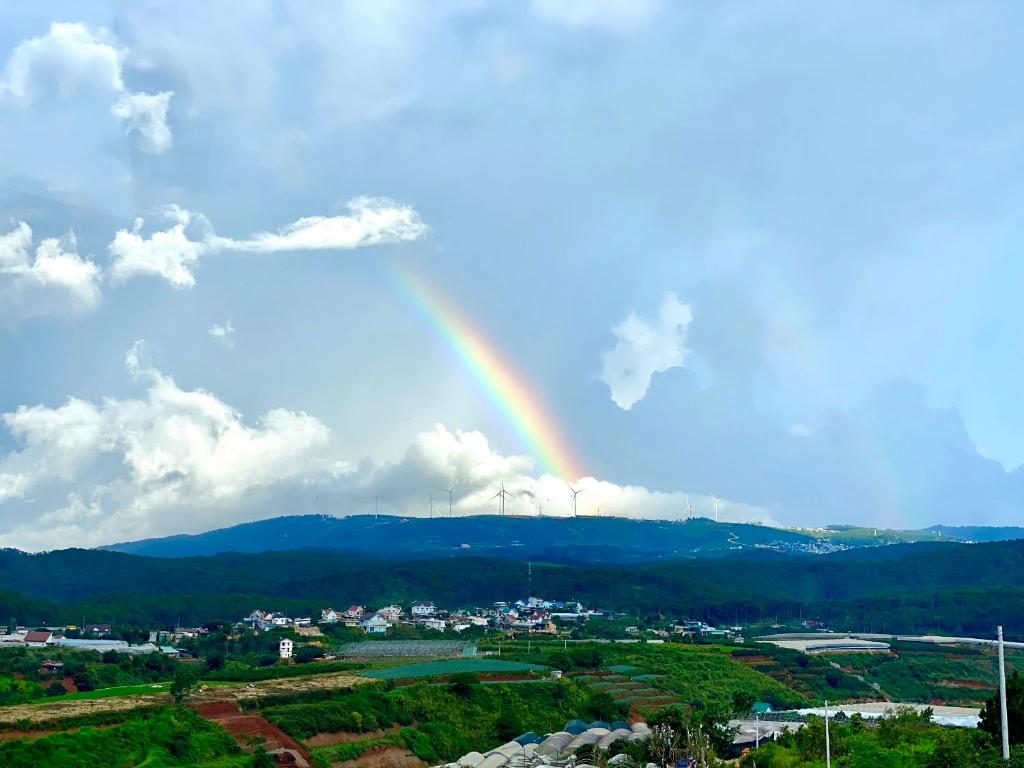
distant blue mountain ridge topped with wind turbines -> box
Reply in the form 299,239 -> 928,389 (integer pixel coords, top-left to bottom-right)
102,515 -> 1024,563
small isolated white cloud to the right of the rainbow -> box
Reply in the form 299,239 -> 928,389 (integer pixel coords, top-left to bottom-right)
600,293 -> 693,411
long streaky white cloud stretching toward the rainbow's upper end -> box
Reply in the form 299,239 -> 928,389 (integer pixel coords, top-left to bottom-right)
109,197 -> 430,289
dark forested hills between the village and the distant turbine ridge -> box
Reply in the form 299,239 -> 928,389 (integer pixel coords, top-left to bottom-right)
6,542 -> 1024,633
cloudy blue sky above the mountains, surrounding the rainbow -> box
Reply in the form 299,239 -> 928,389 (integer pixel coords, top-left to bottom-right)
0,0 -> 1024,549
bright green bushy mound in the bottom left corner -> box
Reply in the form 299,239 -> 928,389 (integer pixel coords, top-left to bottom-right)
0,708 -> 253,768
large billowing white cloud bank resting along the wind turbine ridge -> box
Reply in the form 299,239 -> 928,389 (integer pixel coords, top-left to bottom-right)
0,370 -> 772,550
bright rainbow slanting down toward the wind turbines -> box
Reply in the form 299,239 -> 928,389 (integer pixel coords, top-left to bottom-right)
396,269 -> 584,482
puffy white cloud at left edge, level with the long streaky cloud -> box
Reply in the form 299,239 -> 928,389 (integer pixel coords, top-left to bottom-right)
0,221 -> 101,321
